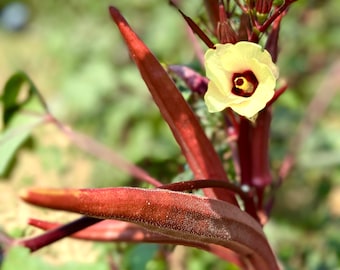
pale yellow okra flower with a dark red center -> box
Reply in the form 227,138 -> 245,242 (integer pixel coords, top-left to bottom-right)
204,41 -> 278,119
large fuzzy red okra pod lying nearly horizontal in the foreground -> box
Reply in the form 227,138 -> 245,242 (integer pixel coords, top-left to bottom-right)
22,187 -> 278,270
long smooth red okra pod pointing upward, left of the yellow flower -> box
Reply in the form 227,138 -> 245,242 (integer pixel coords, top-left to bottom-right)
110,7 -> 237,204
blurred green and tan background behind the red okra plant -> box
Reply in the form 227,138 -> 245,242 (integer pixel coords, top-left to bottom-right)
0,0 -> 340,270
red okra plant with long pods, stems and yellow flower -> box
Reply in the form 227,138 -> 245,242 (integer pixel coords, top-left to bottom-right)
1,0 -> 302,270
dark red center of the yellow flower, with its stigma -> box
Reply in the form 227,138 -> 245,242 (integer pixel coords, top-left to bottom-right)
231,70 -> 259,97
